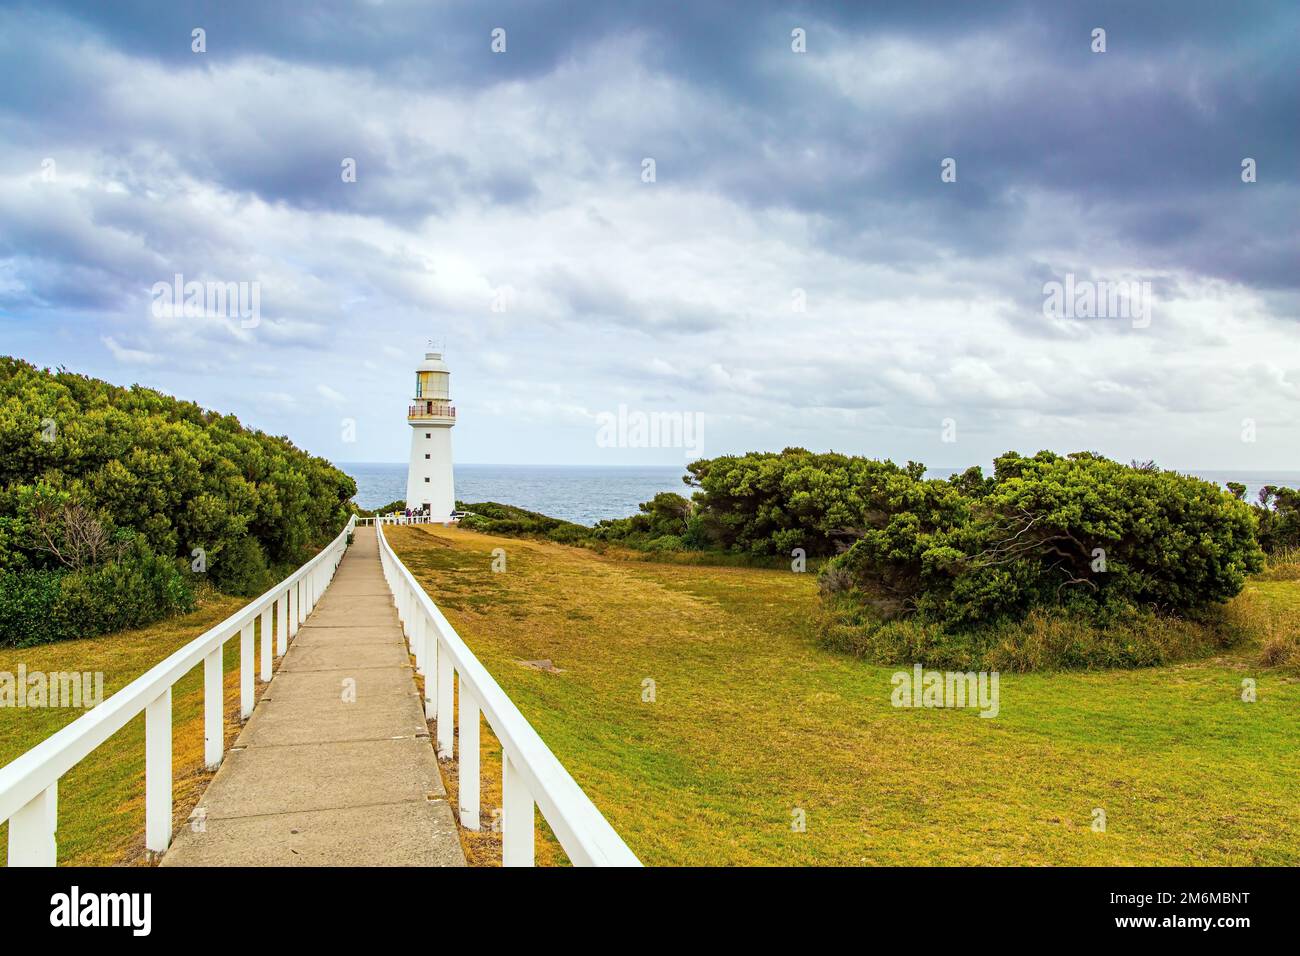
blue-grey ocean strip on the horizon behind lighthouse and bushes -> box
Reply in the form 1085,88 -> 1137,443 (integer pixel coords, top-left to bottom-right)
337,462 -> 1300,524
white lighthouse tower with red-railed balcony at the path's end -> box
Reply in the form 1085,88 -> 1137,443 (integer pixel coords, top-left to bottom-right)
407,352 -> 456,522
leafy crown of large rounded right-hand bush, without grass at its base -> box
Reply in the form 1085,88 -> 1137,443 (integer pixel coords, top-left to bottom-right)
836,451 -> 1264,627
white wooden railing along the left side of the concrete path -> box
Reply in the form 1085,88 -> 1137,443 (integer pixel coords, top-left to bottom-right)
0,518 -> 356,866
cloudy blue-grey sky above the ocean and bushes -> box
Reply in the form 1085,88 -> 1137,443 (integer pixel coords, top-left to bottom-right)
0,0 -> 1300,468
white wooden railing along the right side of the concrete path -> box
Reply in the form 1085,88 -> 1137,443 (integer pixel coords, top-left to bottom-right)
376,518 -> 641,866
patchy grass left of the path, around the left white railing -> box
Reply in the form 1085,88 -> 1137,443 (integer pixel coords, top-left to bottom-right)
0,596 -> 261,866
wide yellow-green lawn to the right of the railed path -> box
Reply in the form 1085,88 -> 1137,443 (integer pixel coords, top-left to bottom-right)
385,527 -> 1300,865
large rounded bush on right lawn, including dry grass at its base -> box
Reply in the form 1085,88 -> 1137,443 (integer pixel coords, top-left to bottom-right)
806,451 -> 1264,667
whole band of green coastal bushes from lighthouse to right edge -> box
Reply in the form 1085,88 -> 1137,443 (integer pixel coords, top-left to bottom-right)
462,449 -> 1300,670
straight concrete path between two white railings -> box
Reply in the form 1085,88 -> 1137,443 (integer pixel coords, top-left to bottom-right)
163,528 -> 465,866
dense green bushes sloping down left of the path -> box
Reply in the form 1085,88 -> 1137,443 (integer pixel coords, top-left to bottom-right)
0,358 -> 356,644
